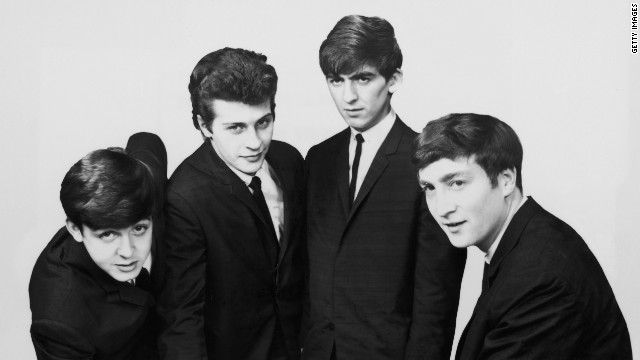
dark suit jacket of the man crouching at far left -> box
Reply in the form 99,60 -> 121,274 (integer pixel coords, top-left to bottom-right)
29,133 -> 167,360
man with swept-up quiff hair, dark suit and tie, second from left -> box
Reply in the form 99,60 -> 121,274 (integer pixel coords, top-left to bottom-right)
159,48 -> 305,360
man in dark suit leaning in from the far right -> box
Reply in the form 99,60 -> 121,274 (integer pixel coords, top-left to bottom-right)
413,114 -> 631,360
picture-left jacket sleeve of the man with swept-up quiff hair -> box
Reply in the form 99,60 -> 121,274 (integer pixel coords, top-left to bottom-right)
156,192 -> 207,360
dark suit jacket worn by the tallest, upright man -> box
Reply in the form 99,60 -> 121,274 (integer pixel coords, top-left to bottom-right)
303,118 -> 466,359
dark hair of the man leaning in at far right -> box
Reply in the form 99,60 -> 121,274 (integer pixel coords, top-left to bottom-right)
412,113 -> 522,191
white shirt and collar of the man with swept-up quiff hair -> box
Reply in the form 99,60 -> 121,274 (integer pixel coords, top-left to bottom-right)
229,160 -> 284,242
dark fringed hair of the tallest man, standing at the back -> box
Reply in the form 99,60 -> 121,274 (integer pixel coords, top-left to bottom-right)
320,15 -> 402,80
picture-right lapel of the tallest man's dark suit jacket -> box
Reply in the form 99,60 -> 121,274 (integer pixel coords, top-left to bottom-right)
347,116 -> 402,221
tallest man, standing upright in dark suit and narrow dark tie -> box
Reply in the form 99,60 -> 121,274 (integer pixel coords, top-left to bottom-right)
303,15 -> 466,360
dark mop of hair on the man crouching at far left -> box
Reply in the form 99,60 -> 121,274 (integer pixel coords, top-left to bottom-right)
60,148 -> 161,229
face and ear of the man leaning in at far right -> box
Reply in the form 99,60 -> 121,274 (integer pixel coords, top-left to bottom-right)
418,157 -> 515,252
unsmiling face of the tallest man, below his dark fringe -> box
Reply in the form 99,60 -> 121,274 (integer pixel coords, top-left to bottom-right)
327,66 -> 402,132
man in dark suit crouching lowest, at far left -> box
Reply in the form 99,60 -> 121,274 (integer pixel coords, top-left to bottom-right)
29,133 -> 167,360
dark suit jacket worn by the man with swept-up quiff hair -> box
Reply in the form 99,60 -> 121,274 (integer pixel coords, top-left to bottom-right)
159,141 -> 305,360
